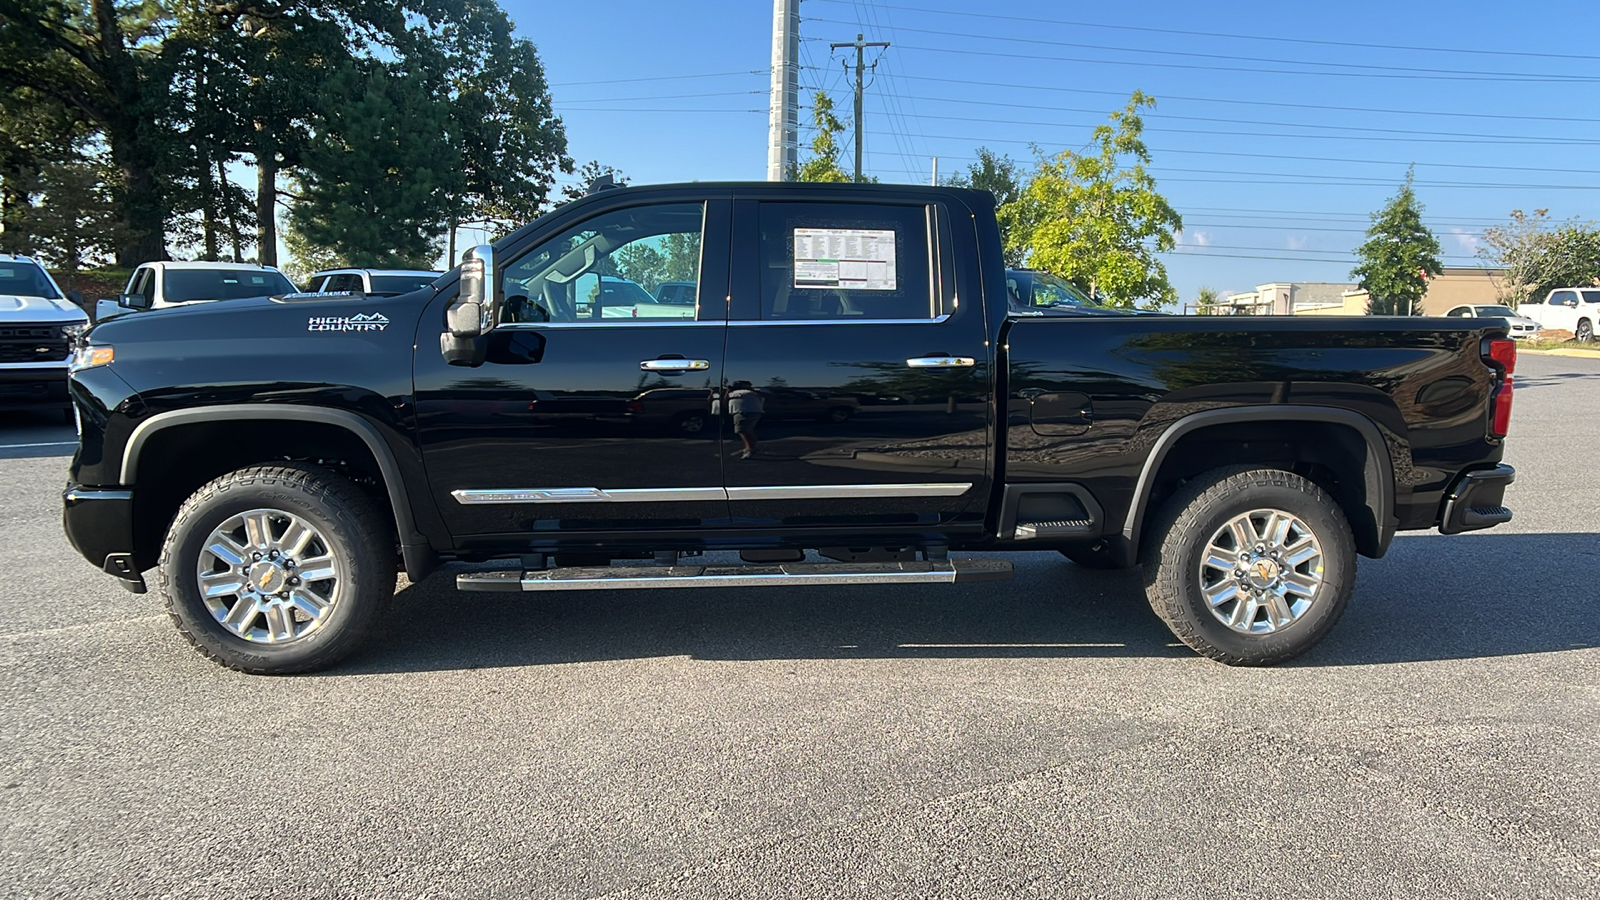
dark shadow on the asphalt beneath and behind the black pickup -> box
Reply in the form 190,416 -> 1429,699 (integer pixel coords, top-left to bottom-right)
338,533 -> 1600,673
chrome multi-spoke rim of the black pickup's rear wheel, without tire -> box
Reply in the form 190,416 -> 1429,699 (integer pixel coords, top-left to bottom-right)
1200,509 -> 1323,634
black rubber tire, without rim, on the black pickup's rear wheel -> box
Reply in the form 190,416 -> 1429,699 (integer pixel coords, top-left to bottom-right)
1142,466 -> 1355,666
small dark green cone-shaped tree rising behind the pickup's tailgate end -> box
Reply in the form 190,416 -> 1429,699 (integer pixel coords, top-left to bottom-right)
1350,171 -> 1443,315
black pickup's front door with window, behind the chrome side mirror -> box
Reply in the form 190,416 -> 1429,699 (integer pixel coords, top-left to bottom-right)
416,191 -> 730,534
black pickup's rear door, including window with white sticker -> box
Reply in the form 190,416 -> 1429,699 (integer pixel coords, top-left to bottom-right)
725,187 -> 992,532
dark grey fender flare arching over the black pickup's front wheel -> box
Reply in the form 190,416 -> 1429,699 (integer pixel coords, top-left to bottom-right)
120,404 -> 438,581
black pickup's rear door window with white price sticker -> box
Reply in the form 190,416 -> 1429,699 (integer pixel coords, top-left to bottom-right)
760,203 -> 946,322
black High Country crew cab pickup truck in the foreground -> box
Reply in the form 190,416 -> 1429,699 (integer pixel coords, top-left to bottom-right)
64,183 -> 1515,673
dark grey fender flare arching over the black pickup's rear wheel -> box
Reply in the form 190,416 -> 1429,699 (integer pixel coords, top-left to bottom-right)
1122,405 -> 1400,559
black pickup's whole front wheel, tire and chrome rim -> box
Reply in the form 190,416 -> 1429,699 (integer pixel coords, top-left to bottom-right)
155,464 -> 395,674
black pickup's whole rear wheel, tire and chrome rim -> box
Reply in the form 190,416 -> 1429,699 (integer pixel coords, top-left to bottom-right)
1144,468 -> 1355,666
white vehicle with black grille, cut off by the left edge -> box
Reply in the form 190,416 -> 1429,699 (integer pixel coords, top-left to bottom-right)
0,253 -> 90,416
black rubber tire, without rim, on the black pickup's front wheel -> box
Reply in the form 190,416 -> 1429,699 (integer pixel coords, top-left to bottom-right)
155,464 -> 397,674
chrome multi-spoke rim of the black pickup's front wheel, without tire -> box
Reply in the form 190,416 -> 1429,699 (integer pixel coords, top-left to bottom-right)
195,509 -> 346,644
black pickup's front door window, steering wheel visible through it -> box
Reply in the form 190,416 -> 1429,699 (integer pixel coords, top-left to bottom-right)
501,203 -> 704,325
